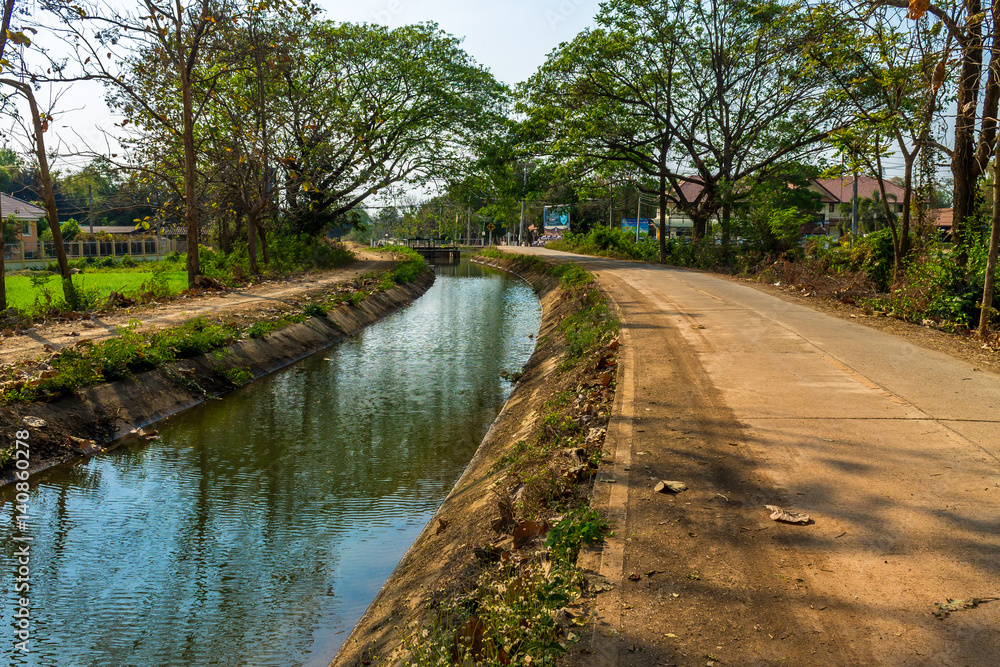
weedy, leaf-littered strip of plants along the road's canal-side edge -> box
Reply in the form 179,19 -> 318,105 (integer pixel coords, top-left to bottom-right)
402,250 -> 619,666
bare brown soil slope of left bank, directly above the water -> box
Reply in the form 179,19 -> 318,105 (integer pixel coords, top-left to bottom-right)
0,268 -> 434,484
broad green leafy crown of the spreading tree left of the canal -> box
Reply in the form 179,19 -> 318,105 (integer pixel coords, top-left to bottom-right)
279,21 -> 507,233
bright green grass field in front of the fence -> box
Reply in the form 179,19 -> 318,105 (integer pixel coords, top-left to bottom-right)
6,269 -> 187,310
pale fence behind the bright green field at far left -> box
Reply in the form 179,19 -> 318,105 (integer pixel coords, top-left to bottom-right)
3,237 -> 182,271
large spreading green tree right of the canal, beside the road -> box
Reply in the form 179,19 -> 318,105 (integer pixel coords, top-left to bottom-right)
521,0 -> 844,259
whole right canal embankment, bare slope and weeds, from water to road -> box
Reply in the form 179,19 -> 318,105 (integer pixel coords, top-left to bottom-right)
331,253 -> 619,667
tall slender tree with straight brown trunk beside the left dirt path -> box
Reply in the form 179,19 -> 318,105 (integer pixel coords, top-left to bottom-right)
43,0 -> 278,288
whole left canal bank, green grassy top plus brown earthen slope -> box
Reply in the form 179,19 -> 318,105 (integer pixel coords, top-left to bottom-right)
0,251 -> 434,479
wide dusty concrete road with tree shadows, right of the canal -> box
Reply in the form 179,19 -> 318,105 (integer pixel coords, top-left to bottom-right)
508,251 -> 1000,666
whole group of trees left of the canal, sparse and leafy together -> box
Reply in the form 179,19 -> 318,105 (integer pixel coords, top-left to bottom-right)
0,0 -> 508,310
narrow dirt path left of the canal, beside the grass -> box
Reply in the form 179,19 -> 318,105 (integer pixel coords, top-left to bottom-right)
0,248 -> 393,365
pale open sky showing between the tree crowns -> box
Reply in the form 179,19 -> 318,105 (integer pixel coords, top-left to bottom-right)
27,0 -> 599,171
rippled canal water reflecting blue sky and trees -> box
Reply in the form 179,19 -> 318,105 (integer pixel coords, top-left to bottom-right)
0,262 -> 541,667
